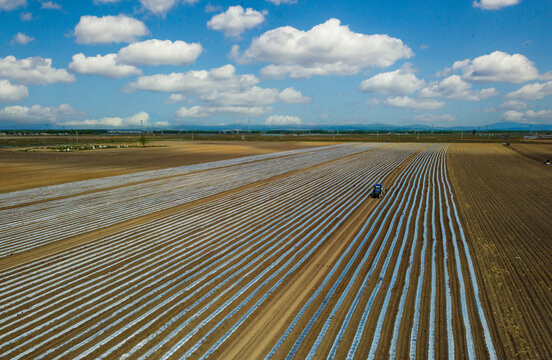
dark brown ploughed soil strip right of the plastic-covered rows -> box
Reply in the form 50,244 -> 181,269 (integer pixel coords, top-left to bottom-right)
448,144 -> 552,359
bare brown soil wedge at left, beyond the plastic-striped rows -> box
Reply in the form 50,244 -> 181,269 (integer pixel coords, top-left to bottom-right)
0,141 -> 327,193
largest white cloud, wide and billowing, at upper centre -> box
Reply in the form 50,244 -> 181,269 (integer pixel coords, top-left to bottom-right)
239,19 -> 414,78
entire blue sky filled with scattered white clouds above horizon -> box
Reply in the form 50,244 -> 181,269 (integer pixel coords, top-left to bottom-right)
0,0 -> 552,129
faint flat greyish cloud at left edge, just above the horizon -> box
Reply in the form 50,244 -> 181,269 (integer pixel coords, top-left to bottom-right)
0,104 -> 81,124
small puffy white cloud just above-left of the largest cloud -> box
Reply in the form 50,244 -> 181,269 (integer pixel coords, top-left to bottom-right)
207,5 -> 268,37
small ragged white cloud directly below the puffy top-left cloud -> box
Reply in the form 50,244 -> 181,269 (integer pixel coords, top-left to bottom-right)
69,53 -> 142,78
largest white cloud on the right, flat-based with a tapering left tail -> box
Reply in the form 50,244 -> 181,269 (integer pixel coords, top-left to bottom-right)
437,51 -> 539,84
